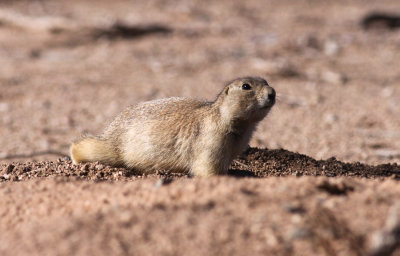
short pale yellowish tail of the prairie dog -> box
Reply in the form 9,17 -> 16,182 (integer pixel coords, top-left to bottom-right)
71,137 -> 120,165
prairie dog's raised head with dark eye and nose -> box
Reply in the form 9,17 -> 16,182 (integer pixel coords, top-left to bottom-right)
217,77 -> 276,122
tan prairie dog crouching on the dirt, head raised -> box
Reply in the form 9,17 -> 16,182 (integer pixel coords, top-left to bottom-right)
71,77 -> 275,176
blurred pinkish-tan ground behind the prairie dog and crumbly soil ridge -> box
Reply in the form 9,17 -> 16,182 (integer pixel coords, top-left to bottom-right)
0,0 -> 400,164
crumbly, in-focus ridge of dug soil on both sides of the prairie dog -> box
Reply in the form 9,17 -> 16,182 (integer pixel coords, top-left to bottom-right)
0,148 -> 400,181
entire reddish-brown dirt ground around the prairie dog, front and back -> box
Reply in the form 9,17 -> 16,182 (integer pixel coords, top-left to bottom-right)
0,0 -> 400,255
